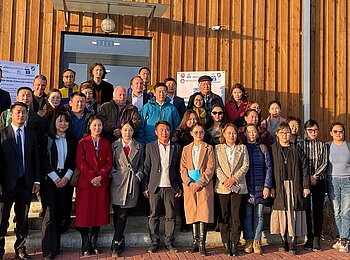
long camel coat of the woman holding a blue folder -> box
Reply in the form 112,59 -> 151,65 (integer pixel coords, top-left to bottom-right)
180,142 -> 215,224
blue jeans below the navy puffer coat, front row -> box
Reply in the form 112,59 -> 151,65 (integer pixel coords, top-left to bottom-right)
243,203 -> 264,241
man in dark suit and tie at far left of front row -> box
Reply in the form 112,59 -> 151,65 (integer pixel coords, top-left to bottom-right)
0,102 -> 40,259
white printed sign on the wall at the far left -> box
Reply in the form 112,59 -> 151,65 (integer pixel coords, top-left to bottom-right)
0,60 -> 39,102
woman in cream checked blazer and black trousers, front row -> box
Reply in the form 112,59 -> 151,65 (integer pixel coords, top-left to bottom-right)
215,123 -> 249,256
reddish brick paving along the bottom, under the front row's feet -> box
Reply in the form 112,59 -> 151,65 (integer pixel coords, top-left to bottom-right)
5,243 -> 350,260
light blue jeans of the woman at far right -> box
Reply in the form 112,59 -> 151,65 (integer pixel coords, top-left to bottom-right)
327,176 -> 350,239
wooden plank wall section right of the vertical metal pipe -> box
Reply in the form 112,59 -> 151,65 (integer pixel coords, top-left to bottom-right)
311,0 -> 350,140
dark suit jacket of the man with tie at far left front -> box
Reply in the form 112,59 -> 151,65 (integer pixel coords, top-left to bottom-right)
0,125 -> 40,192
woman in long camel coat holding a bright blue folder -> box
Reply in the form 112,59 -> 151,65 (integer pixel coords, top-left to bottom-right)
180,125 -> 215,256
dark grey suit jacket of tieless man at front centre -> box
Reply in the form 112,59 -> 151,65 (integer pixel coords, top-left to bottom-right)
142,140 -> 181,193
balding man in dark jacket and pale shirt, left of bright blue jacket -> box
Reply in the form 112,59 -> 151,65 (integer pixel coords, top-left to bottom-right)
127,76 -> 150,112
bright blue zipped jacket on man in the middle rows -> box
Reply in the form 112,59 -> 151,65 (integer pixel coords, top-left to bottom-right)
137,97 -> 181,145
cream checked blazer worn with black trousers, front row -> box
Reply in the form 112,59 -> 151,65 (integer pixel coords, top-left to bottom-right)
215,144 -> 249,194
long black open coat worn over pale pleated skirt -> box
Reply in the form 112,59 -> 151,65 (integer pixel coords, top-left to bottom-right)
271,143 -> 310,210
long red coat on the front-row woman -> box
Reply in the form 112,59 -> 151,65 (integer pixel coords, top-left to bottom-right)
75,136 -> 112,227
